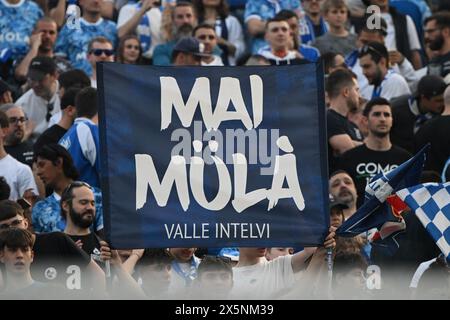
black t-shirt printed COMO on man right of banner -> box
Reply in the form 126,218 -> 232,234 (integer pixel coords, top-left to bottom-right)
338,144 -> 411,207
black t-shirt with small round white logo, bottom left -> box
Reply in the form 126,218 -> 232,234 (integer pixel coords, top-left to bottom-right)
31,232 -> 91,284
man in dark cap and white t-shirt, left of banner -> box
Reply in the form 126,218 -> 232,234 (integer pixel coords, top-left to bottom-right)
15,56 -> 60,135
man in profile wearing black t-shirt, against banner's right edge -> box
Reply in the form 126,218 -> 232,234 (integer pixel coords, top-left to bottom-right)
326,69 -> 362,172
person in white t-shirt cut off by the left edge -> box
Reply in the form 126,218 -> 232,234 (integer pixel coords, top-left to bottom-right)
0,110 -> 39,203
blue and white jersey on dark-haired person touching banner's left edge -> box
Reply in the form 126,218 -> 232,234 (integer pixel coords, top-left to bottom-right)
59,118 -> 100,188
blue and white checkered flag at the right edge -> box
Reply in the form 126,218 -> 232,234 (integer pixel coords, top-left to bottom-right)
397,182 -> 450,263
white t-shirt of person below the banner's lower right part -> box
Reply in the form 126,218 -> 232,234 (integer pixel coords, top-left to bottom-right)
230,255 -> 295,300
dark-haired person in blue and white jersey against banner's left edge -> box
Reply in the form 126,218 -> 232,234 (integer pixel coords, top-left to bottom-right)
59,88 -> 100,188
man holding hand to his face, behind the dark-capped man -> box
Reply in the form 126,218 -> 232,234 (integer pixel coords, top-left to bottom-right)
14,17 -> 71,80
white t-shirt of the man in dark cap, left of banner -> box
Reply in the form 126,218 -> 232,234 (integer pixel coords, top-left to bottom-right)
15,81 -> 61,134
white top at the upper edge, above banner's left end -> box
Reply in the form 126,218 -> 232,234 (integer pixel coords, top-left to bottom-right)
117,3 -> 163,59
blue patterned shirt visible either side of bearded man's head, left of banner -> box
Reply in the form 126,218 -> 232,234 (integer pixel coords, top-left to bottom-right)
31,188 -> 103,233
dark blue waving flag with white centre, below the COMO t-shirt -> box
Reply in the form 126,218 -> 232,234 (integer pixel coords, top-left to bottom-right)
336,144 -> 429,237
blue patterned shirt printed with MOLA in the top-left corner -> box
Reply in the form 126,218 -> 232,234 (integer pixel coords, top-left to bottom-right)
0,0 -> 44,60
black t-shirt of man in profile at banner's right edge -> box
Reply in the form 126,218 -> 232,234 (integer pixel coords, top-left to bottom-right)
327,109 -> 362,173
